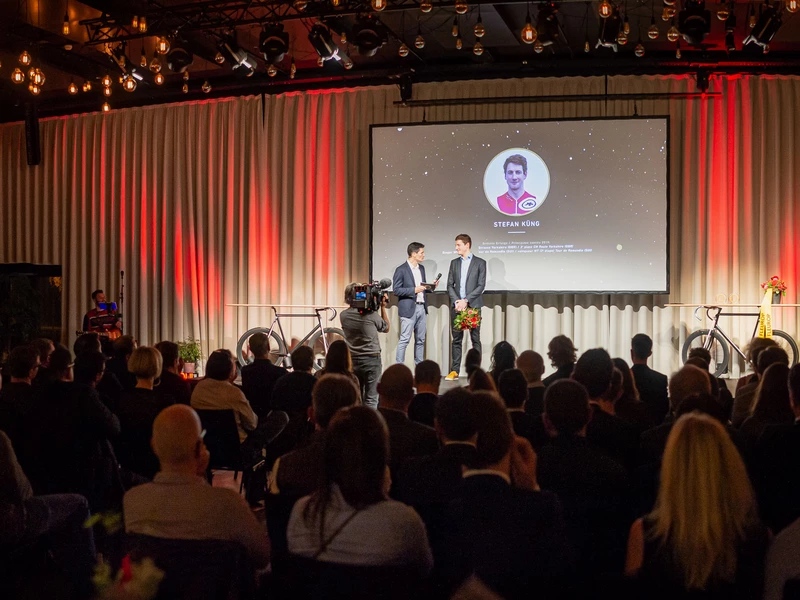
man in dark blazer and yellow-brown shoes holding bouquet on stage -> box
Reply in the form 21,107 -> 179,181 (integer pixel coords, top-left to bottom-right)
445,233 -> 486,381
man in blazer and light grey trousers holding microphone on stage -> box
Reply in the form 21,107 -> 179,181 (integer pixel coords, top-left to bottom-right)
392,242 -> 438,365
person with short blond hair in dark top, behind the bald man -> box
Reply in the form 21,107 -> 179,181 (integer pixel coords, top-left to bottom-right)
116,346 -> 174,479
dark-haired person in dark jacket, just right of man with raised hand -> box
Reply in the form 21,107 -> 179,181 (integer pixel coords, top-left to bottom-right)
537,379 -> 633,591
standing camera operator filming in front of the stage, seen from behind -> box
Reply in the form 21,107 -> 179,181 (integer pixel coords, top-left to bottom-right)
340,283 -> 389,409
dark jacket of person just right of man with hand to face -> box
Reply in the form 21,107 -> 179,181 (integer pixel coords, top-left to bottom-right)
537,435 -> 635,575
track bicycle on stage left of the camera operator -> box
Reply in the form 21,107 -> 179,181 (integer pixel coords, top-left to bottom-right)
236,306 -> 344,372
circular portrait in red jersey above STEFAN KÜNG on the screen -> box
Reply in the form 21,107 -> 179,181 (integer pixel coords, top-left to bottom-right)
483,148 -> 550,217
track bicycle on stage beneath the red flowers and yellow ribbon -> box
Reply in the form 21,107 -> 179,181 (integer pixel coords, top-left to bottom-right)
681,305 -> 798,377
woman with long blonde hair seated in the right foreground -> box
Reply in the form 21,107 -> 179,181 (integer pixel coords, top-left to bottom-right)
625,412 -> 769,599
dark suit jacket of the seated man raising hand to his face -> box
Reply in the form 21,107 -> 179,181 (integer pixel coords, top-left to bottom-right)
434,474 -> 572,600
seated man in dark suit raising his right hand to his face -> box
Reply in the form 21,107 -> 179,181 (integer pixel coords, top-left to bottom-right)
436,393 -> 572,600
